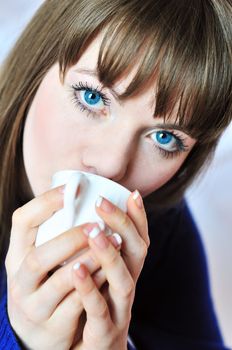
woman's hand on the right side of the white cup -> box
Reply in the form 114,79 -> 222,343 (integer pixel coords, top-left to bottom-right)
71,191 -> 149,350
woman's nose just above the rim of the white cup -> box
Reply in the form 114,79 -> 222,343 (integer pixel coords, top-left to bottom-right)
82,130 -> 136,182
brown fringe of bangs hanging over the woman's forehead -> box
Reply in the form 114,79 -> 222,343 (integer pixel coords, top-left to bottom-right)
60,1 -> 231,143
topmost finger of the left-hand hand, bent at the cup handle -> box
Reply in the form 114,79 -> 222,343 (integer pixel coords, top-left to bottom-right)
7,186 -> 63,274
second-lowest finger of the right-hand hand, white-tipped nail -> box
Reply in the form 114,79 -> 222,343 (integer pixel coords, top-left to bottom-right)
89,228 -> 134,325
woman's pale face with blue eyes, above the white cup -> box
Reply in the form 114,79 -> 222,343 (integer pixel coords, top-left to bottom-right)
23,37 -> 195,197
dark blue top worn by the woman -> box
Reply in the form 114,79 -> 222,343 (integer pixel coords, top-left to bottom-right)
0,202 -> 228,350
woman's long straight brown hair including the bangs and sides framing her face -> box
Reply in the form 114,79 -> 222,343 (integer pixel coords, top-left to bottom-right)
0,0 -> 232,262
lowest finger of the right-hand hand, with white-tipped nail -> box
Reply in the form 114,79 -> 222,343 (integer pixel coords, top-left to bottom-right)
73,263 -> 112,337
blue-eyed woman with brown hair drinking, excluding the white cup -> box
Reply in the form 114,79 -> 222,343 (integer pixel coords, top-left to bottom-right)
0,0 -> 231,350
